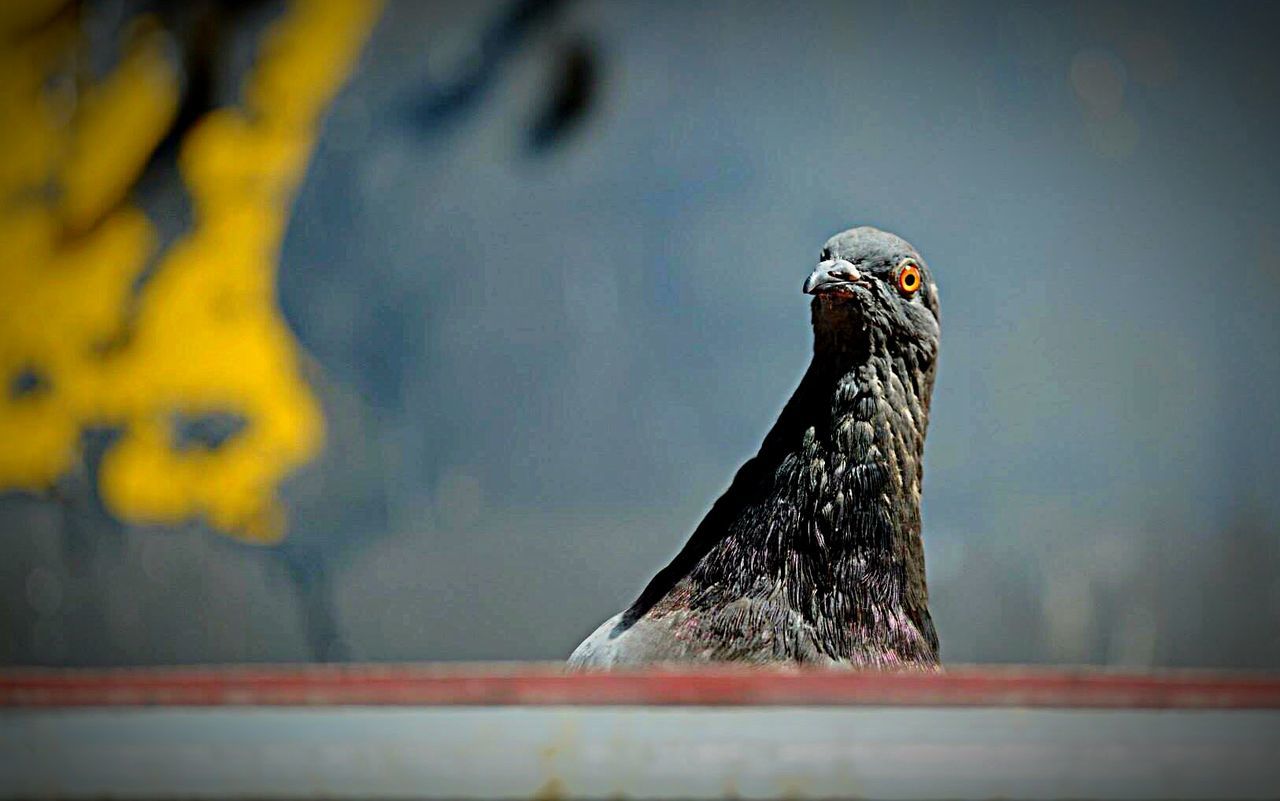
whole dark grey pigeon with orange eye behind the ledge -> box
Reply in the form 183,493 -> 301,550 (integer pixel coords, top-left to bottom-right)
568,226 -> 940,669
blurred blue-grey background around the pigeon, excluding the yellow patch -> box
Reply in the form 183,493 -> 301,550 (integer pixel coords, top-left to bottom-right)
0,0 -> 1280,668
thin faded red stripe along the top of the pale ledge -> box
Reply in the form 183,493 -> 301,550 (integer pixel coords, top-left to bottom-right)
0,663 -> 1280,709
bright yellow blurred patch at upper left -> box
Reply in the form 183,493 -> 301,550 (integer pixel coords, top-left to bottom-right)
0,0 -> 380,543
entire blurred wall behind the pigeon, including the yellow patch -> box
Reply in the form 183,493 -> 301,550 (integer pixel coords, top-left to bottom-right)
0,0 -> 1280,668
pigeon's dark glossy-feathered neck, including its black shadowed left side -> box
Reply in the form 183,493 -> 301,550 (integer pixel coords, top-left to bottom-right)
616,325 -> 937,667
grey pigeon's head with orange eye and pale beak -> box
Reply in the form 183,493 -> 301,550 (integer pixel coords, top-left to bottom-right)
804,225 -> 938,353
